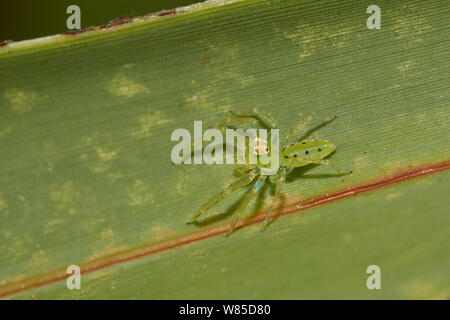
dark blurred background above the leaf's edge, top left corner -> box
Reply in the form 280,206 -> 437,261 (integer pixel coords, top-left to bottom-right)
0,0 -> 203,41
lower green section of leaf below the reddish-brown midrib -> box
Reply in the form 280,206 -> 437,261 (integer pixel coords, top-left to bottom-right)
10,171 -> 450,299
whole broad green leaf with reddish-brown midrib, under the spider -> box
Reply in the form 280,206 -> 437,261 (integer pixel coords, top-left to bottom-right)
0,0 -> 450,299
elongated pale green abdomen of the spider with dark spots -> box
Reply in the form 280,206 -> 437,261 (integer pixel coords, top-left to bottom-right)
280,140 -> 336,168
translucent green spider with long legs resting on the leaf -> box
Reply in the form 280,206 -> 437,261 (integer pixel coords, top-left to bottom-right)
187,108 -> 352,236
